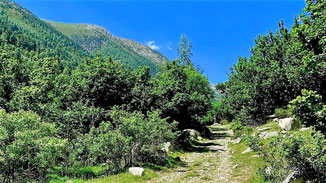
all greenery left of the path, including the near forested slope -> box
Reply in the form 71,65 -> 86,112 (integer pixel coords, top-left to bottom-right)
0,1 -> 213,182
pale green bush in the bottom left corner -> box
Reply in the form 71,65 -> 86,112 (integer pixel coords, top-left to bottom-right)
0,110 -> 67,182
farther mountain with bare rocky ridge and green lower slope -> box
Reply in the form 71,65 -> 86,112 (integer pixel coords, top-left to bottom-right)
44,20 -> 168,74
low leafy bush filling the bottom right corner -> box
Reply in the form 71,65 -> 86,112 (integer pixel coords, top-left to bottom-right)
248,129 -> 326,182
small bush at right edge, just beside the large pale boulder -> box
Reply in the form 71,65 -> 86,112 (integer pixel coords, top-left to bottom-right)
289,90 -> 326,133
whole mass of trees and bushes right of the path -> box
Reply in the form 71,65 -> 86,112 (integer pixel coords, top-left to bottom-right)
216,0 -> 326,182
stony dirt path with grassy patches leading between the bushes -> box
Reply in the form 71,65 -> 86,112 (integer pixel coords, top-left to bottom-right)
149,125 -> 237,183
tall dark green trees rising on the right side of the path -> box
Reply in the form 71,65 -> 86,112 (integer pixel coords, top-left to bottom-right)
226,1 -> 326,124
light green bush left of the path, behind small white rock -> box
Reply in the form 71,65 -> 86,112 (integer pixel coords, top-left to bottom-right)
77,109 -> 175,171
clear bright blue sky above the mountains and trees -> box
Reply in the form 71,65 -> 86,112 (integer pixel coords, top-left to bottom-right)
15,0 -> 305,83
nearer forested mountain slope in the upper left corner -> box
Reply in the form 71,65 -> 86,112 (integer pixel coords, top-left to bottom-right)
0,0 -> 90,67
